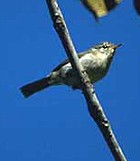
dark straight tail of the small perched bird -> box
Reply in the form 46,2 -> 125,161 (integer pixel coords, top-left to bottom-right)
20,77 -> 51,97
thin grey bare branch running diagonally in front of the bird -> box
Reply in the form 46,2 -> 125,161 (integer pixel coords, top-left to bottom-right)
46,0 -> 126,161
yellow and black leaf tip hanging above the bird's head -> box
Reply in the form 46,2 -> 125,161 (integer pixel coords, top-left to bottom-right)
81,0 -> 121,19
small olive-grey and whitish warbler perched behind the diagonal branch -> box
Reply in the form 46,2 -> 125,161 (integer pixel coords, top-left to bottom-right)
20,42 -> 122,97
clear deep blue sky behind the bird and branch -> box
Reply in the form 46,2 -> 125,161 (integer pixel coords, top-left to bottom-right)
0,0 -> 140,161
